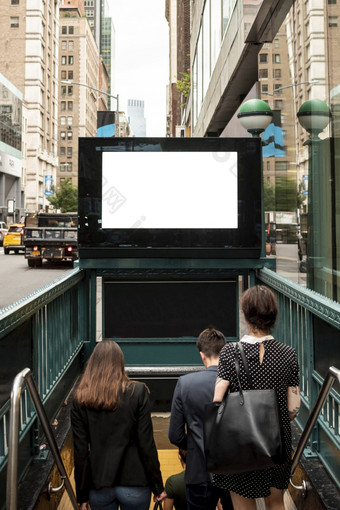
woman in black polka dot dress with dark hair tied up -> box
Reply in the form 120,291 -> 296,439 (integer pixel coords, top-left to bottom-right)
213,286 -> 300,510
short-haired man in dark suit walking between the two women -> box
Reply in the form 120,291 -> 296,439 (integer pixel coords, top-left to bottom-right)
169,328 -> 232,510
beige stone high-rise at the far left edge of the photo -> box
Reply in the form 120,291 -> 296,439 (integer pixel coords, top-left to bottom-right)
0,0 -> 59,211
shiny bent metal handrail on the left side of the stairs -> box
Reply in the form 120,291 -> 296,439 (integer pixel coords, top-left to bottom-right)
6,368 -> 78,510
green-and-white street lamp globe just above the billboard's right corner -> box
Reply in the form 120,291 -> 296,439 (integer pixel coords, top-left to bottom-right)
237,99 -> 273,137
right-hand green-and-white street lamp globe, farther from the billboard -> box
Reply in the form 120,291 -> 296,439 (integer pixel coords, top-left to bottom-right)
297,99 -> 331,138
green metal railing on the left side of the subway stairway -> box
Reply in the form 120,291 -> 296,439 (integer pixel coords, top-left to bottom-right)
0,269 -> 90,508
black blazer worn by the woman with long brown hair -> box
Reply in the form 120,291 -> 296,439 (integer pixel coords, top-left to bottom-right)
71,382 -> 164,503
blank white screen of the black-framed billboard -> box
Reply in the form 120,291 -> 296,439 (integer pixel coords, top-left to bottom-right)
102,151 -> 238,229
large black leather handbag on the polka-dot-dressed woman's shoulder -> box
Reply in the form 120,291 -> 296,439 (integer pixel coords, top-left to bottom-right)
204,342 -> 286,475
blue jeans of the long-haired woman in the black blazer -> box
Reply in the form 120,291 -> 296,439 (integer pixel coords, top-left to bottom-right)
89,487 -> 151,510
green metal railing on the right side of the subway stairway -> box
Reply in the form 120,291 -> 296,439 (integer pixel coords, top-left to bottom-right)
256,269 -> 340,488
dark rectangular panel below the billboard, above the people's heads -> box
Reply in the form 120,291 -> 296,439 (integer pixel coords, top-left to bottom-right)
103,278 -> 237,340
